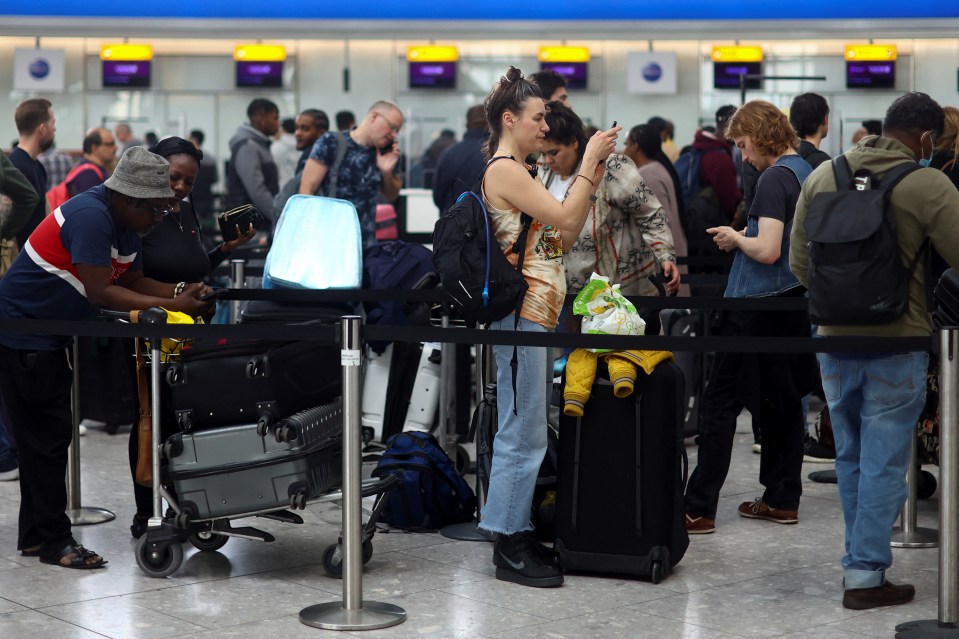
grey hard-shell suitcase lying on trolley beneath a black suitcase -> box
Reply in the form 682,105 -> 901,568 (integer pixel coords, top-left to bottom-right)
164,398 -> 343,520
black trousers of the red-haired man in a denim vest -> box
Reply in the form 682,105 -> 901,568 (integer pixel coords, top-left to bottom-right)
686,312 -> 805,519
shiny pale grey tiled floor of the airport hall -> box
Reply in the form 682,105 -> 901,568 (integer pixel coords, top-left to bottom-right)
0,420 -> 938,639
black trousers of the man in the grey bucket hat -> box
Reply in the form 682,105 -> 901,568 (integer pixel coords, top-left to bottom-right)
0,346 -> 75,556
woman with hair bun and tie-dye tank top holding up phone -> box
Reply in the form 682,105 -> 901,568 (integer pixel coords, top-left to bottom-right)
480,67 -> 620,587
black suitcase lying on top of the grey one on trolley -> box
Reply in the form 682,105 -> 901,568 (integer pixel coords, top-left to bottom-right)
166,340 -> 342,432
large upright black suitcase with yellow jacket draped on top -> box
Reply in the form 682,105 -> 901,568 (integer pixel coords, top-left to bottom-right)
556,362 -> 689,583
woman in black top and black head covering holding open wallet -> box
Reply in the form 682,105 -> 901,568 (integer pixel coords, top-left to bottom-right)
130,137 -> 256,538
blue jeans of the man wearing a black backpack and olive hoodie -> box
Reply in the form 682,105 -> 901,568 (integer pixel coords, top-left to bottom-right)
819,353 -> 929,590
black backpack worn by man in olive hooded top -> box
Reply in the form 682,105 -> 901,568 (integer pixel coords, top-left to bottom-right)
805,155 -> 927,326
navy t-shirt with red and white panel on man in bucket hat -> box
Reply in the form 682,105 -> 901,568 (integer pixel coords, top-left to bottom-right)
0,186 -> 142,350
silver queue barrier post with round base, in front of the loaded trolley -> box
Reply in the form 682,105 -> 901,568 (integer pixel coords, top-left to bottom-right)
300,315 -> 406,630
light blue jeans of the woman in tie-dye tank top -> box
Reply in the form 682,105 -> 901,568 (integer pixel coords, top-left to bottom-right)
480,315 -> 553,535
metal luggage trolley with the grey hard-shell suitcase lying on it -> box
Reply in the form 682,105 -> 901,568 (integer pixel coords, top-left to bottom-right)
100,308 -> 397,577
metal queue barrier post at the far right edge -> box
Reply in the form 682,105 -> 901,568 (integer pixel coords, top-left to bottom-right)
896,327 -> 959,639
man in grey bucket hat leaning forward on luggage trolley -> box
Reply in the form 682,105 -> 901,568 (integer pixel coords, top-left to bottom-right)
0,147 -> 209,568
